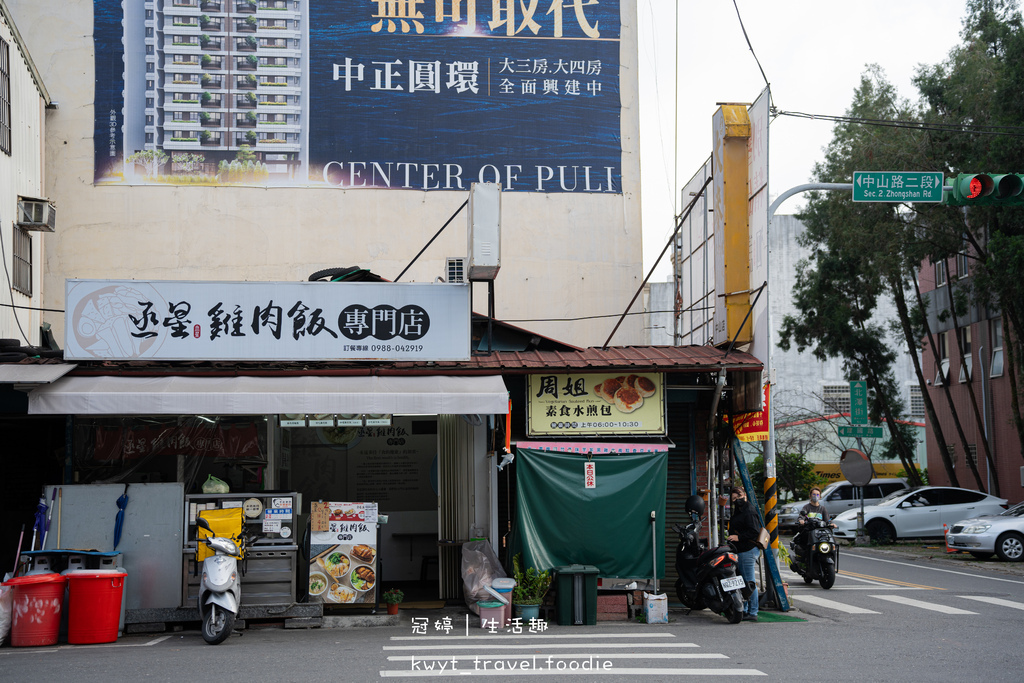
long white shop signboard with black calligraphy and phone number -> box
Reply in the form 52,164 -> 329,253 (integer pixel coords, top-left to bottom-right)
65,280 -> 470,360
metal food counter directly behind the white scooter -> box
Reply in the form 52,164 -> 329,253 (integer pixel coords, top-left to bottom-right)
181,492 -> 305,607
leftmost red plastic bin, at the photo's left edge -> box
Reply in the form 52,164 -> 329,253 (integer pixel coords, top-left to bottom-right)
4,573 -> 66,647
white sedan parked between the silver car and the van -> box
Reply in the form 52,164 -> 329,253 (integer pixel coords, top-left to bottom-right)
833,486 -> 1007,543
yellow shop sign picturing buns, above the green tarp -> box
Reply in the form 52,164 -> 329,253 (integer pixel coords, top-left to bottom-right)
526,373 -> 666,437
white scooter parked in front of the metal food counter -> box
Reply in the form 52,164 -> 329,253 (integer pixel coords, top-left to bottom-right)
196,517 -> 244,645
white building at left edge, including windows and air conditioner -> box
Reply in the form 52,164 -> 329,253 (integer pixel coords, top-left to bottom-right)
0,0 -> 50,348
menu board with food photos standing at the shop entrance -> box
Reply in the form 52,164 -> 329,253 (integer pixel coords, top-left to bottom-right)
309,502 -> 378,605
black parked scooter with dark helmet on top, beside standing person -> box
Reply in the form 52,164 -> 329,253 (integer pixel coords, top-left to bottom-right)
672,496 -> 753,624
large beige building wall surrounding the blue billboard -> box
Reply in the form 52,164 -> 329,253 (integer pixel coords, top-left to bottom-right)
8,0 -> 644,346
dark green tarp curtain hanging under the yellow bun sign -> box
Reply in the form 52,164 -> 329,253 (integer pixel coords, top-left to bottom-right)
511,449 -> 669,579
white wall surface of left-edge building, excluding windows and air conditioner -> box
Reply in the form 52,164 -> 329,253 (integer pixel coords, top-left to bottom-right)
0,6 -> 47,345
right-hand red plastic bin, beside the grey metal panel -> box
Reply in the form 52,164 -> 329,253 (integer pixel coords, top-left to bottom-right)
68,569 -> 125,645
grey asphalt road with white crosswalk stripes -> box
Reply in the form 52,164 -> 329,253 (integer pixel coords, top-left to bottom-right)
0,548 -> 1024,683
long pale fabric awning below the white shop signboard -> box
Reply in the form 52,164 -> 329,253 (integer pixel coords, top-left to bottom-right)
29,375 -> 509,415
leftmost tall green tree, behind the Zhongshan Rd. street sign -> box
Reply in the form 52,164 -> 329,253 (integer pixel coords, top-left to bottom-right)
779,67 -> 933,484
